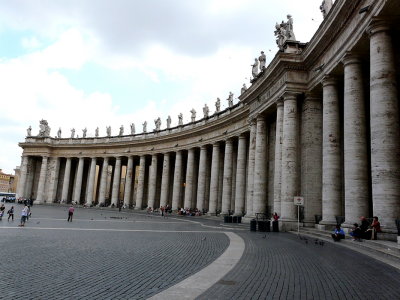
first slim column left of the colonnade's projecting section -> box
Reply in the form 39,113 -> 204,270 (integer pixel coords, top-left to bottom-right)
235,133 -> 247,216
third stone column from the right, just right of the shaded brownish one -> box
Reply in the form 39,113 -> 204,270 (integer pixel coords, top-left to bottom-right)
320,76 -> 342,224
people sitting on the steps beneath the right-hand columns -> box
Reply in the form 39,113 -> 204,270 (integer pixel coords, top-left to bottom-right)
332,216 -> 382,242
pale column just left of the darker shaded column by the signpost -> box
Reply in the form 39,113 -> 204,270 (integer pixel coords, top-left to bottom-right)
281,93 -> 299,220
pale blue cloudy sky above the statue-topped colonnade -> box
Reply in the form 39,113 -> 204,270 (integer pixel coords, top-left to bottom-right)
0,0 -> 322,173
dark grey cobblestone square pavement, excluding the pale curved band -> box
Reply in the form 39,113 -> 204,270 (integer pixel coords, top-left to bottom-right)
0,205 -> 400,299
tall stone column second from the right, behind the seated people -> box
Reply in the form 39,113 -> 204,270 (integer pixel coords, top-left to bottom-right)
343,54 -> 369,227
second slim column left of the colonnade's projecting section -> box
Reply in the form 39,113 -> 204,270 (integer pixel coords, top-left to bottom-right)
221,139 -> 233,215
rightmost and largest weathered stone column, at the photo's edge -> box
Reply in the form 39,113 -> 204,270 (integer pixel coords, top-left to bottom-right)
369,21 -> 400,228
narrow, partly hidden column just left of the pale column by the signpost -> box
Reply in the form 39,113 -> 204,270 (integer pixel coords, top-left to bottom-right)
273,99 -> 283,216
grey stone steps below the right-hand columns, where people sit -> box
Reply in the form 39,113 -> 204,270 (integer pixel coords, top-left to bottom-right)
292,227 -> 400,270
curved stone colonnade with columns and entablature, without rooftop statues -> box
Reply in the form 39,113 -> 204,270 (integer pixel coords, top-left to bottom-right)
17,0 -> 400,232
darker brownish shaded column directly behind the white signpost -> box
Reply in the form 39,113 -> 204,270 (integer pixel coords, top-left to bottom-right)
300,93 -> 322,223
